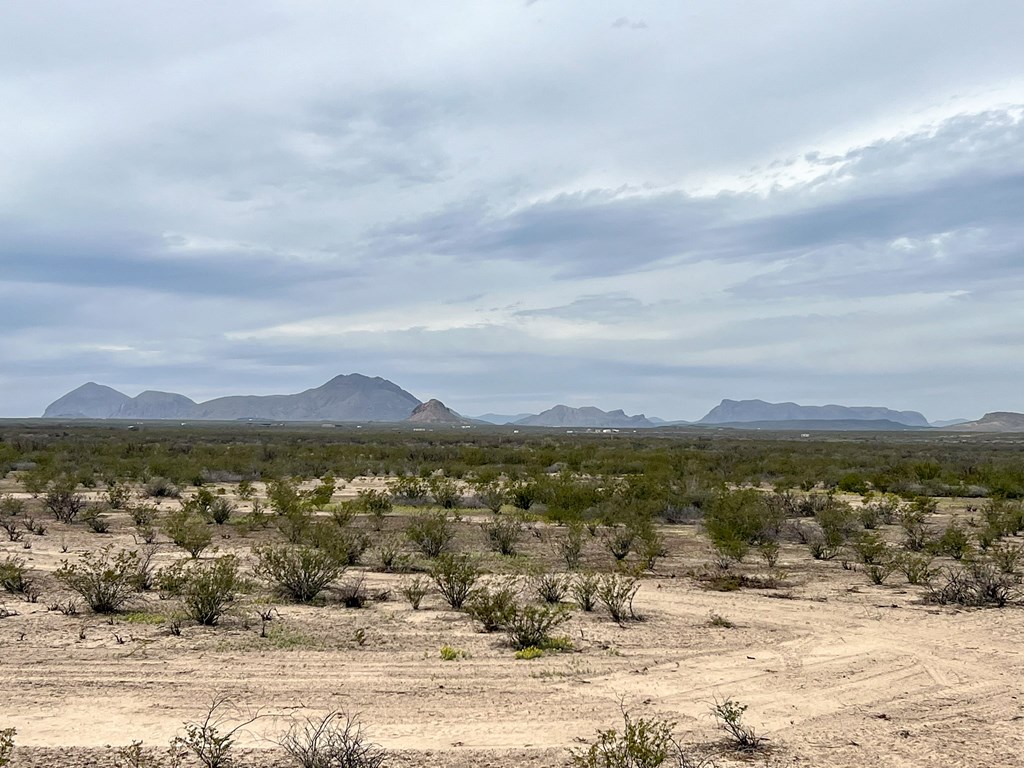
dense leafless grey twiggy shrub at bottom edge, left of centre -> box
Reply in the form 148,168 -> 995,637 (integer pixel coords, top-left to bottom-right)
278,711 -> 387,768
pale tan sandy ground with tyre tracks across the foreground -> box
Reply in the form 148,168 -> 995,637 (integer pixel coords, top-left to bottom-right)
0,483 -> 1024,768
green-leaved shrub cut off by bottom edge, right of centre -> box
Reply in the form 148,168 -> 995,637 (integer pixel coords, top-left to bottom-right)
569,709 -> 709,768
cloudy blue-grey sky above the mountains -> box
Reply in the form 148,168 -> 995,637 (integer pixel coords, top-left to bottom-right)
0,0 -> 1024,419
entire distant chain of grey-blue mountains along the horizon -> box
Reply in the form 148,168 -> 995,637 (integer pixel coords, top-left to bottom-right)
37,374 -> 1024,432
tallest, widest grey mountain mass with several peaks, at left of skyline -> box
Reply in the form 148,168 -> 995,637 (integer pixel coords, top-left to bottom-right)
43,374 -> 420,422
